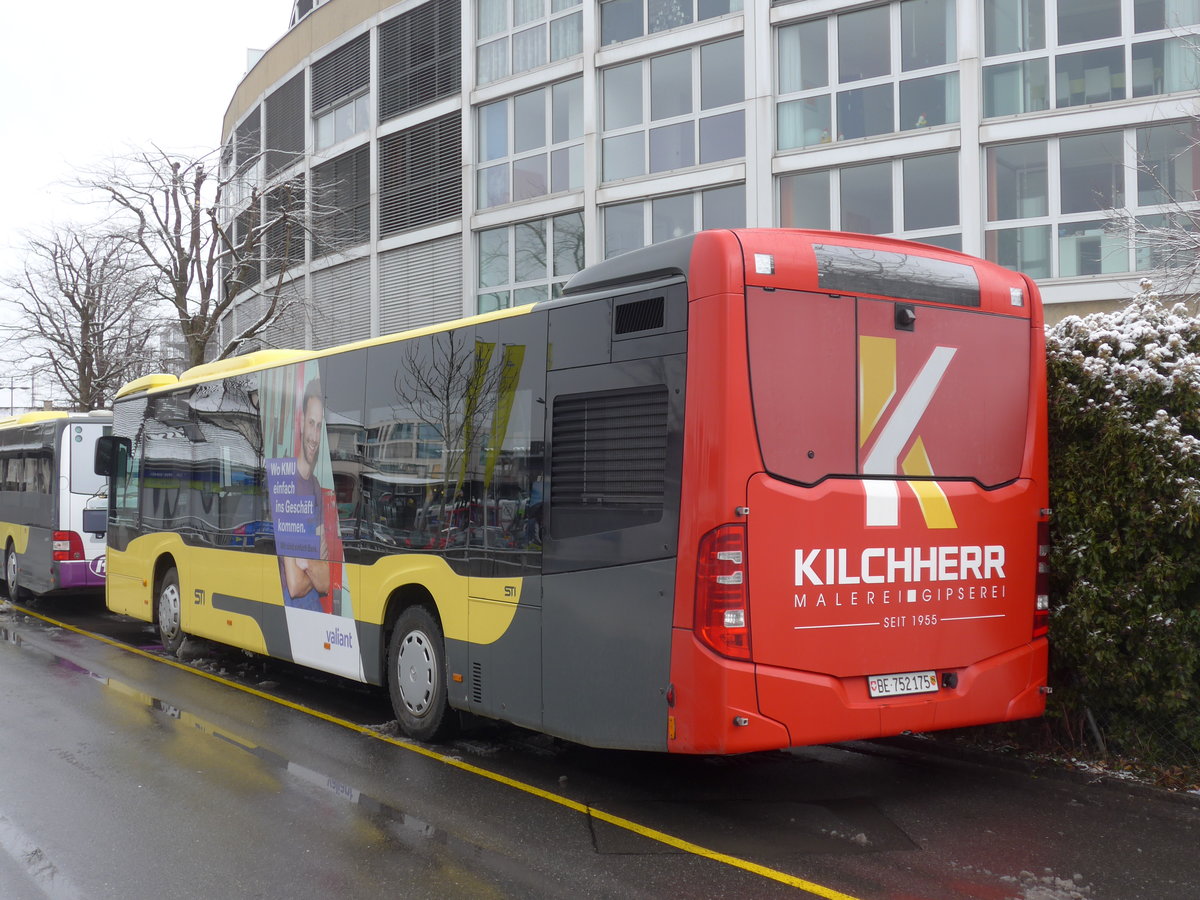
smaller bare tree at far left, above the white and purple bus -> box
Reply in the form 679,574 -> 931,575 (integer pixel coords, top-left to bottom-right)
0,227 -> 163,410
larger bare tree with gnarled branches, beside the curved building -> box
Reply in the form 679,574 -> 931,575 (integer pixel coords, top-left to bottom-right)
80,148 -> 348,366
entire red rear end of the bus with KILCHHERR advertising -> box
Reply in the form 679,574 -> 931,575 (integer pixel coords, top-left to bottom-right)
667,230 -> 1049,752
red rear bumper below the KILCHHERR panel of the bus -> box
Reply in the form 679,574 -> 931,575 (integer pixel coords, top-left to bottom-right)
667,629 -> 1048,754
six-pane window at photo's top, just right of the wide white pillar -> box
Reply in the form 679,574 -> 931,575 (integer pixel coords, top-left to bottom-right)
775,0 -> 960,150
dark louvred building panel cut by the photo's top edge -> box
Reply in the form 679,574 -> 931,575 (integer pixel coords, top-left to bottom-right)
379,0 -> 462,122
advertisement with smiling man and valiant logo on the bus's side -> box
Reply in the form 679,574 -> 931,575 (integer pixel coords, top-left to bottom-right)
259,361 -> 362,678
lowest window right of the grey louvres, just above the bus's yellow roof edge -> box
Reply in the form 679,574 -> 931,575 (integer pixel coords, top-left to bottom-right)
475,212 -> 583,312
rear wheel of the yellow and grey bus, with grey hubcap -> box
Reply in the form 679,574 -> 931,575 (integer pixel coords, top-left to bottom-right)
388,606 -> 457,740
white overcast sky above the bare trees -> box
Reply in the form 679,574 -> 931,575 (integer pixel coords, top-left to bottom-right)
0,0 -> 292,282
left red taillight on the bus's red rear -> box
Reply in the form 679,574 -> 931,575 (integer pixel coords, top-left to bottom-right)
694,524 -> 750,660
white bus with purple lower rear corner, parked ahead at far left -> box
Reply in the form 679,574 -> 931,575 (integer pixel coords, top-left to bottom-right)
0,410 -> 112,602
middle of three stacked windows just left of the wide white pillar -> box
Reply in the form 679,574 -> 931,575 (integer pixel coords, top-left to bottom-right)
601,37 -> 745,181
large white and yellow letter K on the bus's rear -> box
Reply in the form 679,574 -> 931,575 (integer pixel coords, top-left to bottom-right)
858,335 -> 958,528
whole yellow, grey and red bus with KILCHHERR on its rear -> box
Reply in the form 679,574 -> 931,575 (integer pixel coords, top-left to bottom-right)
96,229 -> 1050,754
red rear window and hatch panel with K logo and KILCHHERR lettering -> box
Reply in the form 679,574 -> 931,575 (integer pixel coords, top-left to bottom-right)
746,288 -> 1039,718
